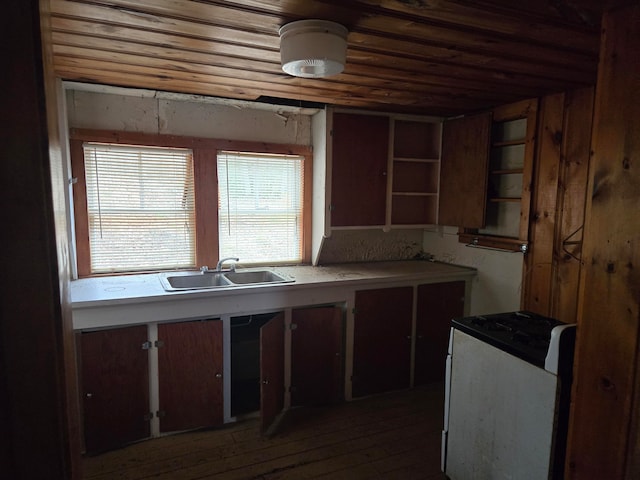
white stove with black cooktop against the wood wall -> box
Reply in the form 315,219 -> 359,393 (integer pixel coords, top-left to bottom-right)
442,312 -> 575,480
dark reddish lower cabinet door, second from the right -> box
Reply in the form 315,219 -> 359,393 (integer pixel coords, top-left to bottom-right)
353,287 -> 413,397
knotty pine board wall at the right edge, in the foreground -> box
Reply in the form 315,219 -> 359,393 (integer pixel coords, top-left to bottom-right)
568,2 -> 640,480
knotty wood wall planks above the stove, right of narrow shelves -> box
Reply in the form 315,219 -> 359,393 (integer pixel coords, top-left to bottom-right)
522,88 -> 594,323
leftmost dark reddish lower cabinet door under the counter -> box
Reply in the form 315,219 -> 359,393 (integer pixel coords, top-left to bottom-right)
79,325 -> 150,453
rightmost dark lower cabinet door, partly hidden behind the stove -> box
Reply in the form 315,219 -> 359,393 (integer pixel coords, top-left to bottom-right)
413,281 -> 465,385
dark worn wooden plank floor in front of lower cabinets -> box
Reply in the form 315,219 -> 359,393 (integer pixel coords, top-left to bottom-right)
83,385 -> 445,480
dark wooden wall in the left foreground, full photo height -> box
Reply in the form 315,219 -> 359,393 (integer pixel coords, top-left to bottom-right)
0,0 -> 80,480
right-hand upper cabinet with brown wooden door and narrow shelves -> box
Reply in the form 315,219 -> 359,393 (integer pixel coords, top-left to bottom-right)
438,99 -> 538,250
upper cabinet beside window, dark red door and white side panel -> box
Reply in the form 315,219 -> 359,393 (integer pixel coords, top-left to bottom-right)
312,108 -> 442,263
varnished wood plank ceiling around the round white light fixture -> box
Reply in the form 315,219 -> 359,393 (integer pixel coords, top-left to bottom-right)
49,0 -> 604,116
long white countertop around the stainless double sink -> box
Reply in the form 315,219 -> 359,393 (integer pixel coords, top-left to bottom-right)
71,261 -> 476,329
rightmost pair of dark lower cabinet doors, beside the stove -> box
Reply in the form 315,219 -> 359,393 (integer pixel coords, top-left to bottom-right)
351,280 -> 470,397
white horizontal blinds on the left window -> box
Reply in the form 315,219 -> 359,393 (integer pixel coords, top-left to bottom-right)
84,143 -> 195,273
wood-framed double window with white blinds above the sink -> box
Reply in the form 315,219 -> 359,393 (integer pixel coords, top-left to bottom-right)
70,129 -> 312,277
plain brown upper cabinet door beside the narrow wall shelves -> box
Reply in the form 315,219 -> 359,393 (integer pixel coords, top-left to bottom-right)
438,113 -> 491,228
